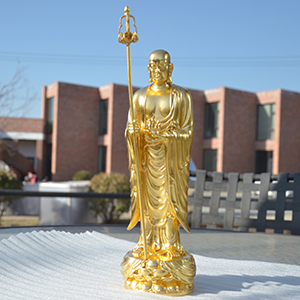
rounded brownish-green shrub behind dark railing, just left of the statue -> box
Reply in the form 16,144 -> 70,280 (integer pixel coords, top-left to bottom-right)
89,173 -> 130,223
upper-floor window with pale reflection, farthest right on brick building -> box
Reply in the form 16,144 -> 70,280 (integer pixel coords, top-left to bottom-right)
256,103 -> 275,141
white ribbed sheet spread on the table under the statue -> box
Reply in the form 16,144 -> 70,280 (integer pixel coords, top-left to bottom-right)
0,228 -> 300,300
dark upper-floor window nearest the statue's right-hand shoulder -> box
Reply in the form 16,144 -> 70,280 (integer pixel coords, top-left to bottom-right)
204,102 -> 219,139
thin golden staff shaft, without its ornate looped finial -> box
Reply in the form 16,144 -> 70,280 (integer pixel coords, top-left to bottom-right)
126,44 -> 147,260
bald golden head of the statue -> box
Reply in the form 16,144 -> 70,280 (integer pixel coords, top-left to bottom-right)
148,50 -> 173,85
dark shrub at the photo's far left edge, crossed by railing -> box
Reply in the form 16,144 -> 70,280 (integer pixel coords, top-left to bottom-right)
0,170 -> 22,225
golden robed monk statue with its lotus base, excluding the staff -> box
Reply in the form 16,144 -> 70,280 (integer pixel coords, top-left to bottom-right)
122,50 -> 196,295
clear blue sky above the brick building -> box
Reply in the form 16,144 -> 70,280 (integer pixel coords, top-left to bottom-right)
0,0 -> 300,118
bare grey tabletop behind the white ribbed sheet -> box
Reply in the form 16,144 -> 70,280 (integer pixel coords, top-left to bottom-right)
0,225 -> 300,265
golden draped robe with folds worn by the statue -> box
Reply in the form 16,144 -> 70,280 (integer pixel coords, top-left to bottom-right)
125,85 -> 193,241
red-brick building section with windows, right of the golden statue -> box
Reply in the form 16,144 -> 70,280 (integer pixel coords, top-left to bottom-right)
195,87 -> 300,174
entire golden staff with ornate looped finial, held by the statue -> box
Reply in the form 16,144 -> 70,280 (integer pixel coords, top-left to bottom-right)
118,6 -> 147,260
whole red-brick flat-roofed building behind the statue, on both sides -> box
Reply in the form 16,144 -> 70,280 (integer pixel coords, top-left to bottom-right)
1,82 -> 300,181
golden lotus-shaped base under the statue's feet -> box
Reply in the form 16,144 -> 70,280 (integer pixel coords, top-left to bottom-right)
121,251 -> 196,296
